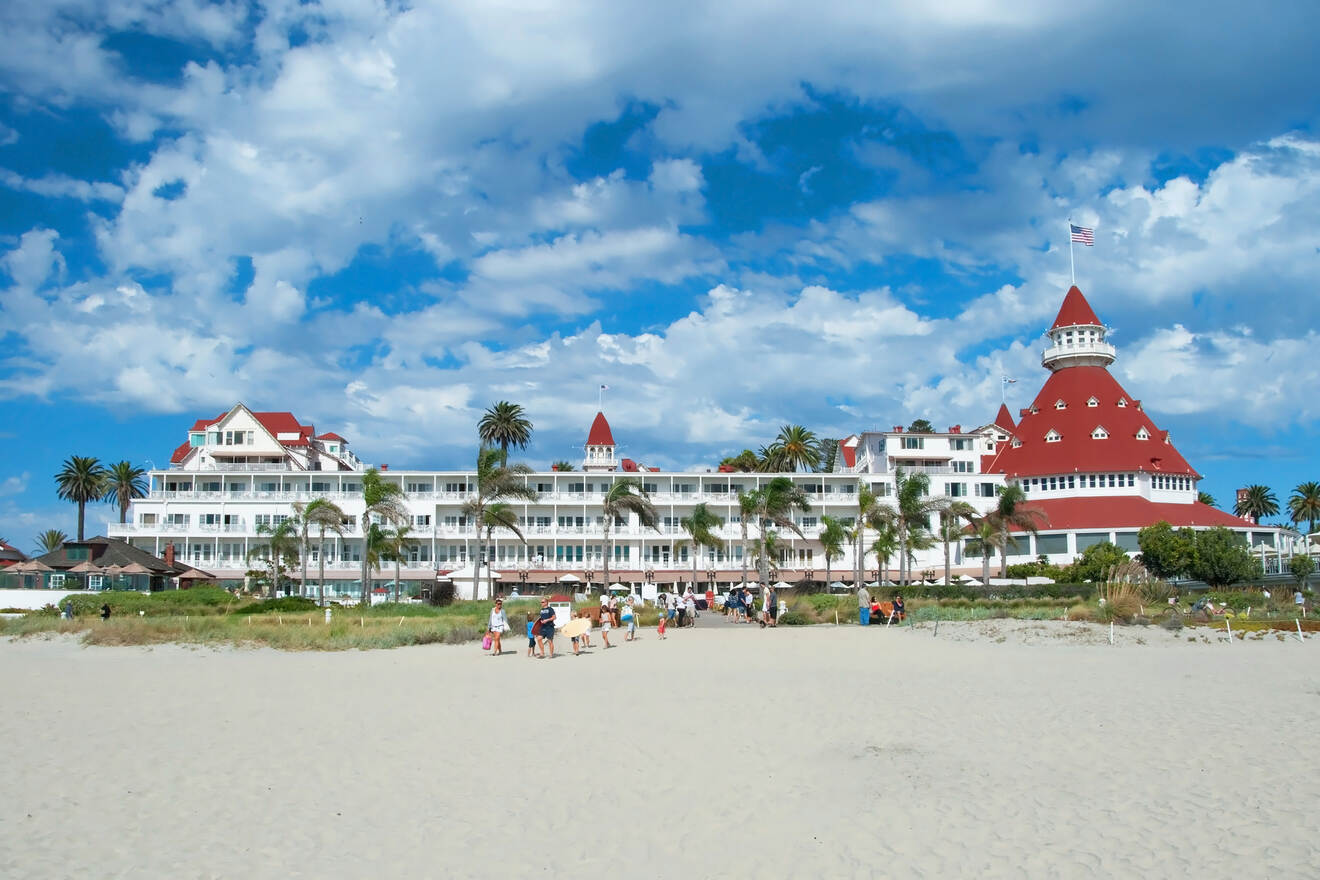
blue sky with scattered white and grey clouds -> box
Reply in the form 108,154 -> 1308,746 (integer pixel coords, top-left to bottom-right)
0,0 -> 1320,549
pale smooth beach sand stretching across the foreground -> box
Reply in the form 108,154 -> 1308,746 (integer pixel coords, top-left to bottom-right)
0,621 -> 1320,880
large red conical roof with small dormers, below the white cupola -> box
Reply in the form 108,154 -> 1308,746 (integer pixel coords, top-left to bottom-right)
987,367 -> 1200,476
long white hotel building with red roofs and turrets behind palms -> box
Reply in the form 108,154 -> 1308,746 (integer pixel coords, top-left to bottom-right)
108,288 -> 1282,595
